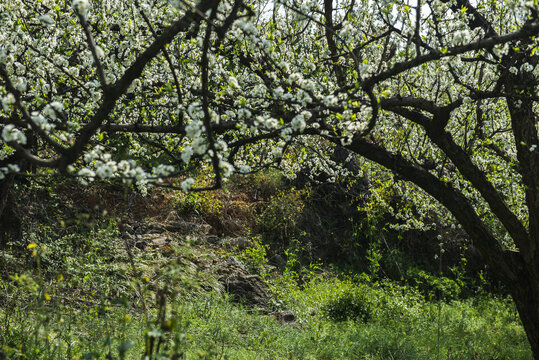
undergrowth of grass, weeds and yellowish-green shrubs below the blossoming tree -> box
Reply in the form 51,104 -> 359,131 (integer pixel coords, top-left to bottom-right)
0,173 -> 532,360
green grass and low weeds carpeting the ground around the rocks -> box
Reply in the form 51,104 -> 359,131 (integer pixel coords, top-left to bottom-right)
0,223 -> 532,360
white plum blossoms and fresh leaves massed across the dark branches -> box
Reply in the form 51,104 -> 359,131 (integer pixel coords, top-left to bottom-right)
0,0 -> 537,248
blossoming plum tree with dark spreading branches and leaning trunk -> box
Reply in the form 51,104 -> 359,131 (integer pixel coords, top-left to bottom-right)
0,0 -> 539,359
